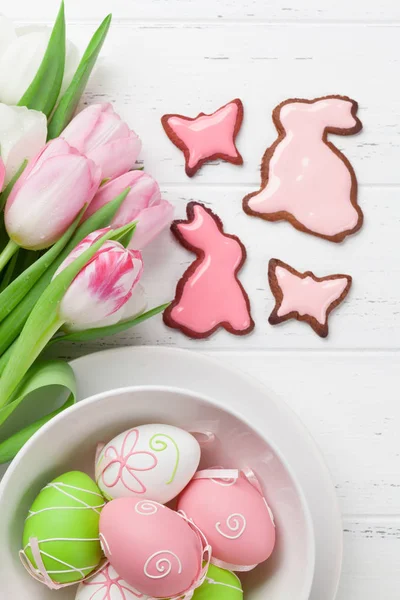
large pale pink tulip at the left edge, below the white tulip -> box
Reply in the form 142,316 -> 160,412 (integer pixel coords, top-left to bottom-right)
5,138 -> 101,250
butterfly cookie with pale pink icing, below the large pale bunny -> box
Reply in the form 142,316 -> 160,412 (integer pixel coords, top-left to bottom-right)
268,258 -> 352,337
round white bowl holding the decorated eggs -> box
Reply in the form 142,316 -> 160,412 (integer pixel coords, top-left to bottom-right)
0,387 -> 315,600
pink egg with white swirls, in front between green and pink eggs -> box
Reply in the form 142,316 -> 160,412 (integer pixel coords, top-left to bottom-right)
100,498 -> 203,598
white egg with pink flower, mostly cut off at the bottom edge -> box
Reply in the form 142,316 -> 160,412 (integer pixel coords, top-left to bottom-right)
75,565 -> 146,600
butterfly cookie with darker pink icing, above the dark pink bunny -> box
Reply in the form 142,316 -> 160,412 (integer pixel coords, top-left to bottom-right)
161,98 -> 243,177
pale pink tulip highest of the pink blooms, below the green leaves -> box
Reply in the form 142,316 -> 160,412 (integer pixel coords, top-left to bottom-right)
62,104 -> 142,179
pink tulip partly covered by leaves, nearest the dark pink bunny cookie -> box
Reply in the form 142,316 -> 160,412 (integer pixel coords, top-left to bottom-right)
85,171 -> 174,250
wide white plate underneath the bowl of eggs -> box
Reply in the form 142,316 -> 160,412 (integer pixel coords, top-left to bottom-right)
71,346 -> 343,600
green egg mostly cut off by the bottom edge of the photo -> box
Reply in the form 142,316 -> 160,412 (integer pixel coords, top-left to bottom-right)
193,565 -> 243,600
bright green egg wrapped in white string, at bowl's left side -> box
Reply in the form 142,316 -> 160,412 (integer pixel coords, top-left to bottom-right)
23,471 -> 104,583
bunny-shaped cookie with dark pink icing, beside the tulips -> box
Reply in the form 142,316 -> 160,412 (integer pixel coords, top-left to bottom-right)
164,202 -> 254,338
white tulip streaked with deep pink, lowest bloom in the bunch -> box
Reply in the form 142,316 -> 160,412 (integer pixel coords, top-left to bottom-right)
54,229 -> 143,329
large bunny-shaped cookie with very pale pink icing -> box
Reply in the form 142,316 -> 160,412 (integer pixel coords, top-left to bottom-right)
243,96 -> 363,242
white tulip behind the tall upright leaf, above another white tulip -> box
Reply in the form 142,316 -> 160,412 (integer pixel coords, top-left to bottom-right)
0,16 -> 79,105
